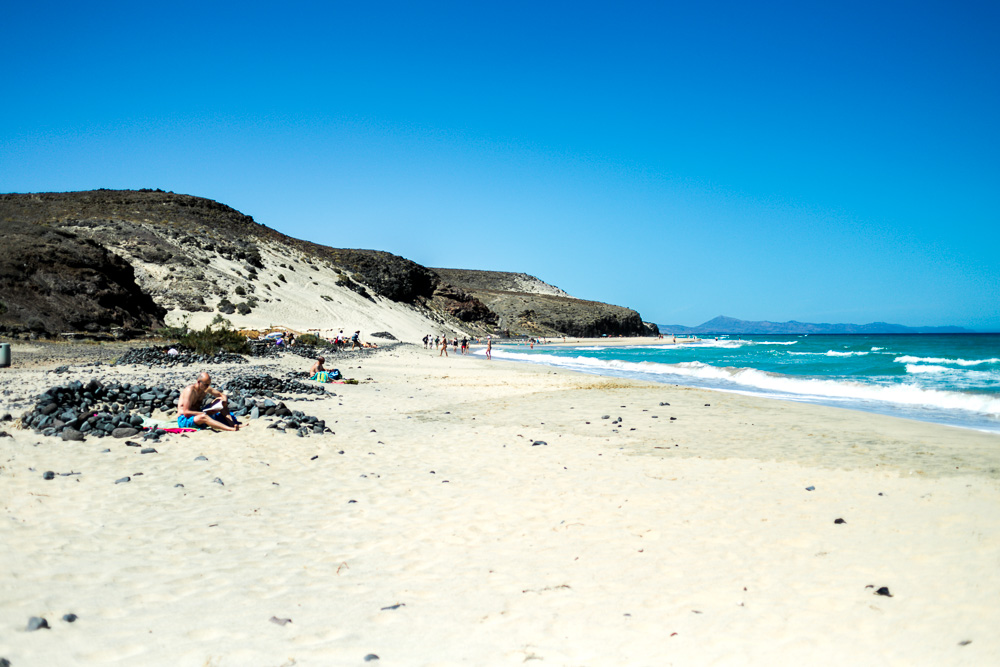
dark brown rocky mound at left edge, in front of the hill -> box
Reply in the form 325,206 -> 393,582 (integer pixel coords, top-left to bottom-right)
0,220 -> 166,335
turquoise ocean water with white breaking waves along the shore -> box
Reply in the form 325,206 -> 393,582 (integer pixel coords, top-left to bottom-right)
484,334 -> 1000,433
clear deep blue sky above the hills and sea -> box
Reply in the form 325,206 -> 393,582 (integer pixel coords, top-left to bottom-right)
0,1 -> 1000,331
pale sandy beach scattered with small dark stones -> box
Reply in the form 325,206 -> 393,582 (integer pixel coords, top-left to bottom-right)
0,343 -> 1000,667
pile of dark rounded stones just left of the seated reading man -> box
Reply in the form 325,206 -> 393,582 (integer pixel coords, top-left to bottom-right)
22,380 -> 180,440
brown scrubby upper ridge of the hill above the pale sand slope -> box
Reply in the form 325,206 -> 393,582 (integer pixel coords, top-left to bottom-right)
0,190 -> 438,309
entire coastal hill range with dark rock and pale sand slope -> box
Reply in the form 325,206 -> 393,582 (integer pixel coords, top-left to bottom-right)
0,190 -> 664,340
